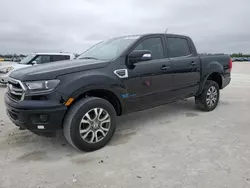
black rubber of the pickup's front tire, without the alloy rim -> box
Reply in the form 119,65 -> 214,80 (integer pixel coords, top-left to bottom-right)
63,97 -> 116,151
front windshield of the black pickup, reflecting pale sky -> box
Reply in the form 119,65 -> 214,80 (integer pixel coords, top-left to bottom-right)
77,36 -> 140,60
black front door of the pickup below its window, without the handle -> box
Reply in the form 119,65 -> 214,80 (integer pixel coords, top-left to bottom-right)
123,59 -> 172,109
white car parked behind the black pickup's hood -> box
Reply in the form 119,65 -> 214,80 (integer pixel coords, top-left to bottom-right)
0,53 -> 75,84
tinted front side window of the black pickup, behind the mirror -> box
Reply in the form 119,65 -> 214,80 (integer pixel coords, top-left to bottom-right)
134,38 -> 164,59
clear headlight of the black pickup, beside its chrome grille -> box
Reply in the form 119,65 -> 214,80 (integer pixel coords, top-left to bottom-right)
24,80 -> 60,94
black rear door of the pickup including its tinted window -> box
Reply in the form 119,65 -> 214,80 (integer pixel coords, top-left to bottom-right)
166,37 -> 200,98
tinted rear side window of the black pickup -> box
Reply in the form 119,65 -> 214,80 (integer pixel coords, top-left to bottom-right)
167,38 -> 191,57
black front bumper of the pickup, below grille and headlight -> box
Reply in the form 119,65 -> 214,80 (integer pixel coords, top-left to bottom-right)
4,93 -> 67,132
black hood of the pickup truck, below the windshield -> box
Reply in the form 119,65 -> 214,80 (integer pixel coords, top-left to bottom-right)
10,59 -> 109,81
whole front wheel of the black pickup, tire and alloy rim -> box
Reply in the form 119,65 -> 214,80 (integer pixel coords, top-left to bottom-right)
63,97 -> 116,151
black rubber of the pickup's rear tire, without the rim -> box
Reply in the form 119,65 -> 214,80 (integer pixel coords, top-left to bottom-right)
195,80 -> 220,112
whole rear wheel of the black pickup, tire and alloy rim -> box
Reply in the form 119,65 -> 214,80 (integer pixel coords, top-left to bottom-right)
195,80 -> 220,111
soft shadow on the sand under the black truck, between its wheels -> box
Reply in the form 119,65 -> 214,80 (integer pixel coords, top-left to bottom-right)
109,99 -> 199,146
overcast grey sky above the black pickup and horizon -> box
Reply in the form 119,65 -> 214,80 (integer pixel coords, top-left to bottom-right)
0,0 -> 250,54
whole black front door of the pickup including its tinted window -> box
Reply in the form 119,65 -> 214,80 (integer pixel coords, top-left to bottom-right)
120,37 -> 172,109
